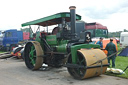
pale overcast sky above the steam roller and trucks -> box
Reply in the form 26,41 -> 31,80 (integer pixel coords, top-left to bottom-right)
0,0 -> 128,32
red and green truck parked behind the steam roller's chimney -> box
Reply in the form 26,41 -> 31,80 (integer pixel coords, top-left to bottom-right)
68,20 -> 108,38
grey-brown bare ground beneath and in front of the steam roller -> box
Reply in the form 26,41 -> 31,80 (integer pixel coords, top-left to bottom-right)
0,58 -> 128,85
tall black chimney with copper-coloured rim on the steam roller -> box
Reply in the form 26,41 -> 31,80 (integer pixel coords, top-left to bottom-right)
69,6 -> 76,39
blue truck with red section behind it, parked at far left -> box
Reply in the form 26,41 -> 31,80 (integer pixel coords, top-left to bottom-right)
0,29 -> 30,51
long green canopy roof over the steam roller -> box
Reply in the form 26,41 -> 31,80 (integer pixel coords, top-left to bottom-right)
22,12 -> 81,27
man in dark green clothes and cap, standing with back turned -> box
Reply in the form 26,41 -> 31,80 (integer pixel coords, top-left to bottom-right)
105,38 -> 117,68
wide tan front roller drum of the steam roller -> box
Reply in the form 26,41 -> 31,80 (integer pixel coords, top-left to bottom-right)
67,49 -> 108,79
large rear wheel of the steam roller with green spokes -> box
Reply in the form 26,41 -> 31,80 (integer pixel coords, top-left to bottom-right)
24,41 -> 44,70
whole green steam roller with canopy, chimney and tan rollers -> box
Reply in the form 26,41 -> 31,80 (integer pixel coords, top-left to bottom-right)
22,6 -> 108,79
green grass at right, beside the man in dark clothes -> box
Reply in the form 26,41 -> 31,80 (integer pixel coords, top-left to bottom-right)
105,44 -> 128,78
